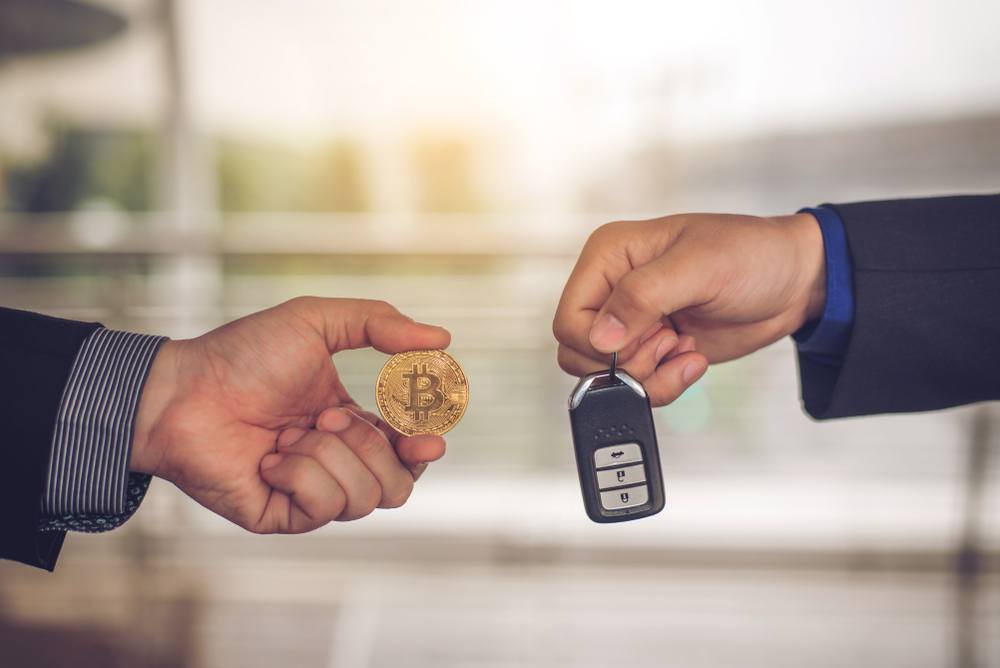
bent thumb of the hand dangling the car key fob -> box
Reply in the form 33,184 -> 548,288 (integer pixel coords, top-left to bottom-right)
590,252 -> 700,353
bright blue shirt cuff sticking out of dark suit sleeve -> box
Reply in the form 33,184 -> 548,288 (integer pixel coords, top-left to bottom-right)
792,206 -> 854,365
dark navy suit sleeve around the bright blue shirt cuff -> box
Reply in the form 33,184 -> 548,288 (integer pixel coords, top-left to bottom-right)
799,195 -> 1000,419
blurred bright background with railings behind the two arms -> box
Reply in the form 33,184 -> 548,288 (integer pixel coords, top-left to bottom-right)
0,0 -> 1000,668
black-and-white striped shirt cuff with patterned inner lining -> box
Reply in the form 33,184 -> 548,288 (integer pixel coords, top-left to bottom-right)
40,329 -> 166,531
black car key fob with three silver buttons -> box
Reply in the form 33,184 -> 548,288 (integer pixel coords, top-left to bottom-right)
569,355 -> 664,522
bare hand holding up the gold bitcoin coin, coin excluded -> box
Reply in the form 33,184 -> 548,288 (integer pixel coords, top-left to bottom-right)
129,297 -> 451,533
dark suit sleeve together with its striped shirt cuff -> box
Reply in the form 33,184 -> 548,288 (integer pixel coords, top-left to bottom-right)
0,309 -> 165,570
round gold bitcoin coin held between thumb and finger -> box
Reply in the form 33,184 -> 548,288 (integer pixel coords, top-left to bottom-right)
375,350 -> 469,436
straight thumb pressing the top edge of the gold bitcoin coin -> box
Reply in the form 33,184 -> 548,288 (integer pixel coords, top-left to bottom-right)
294,297 -> 451,354
